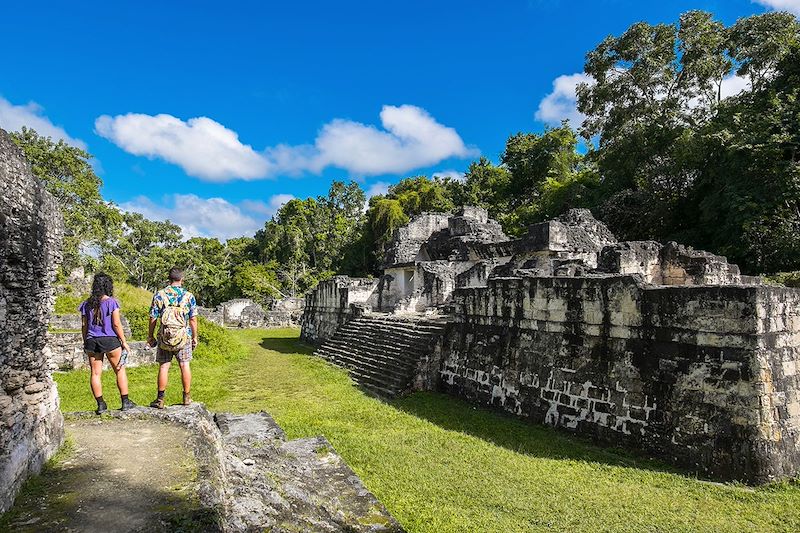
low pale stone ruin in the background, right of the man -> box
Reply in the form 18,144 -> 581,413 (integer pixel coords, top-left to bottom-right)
198,297 -> 305,328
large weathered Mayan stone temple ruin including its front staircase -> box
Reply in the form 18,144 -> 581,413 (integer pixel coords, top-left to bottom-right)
302,207 -> 800,484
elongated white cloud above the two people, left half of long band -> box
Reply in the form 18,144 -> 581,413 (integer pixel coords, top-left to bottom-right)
95,113 -> 269,181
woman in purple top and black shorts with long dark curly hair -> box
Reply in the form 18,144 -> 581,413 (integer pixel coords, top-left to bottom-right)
78,273 -> 136,415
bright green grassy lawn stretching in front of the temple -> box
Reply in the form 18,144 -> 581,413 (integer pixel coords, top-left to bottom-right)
56,330 -> 800,532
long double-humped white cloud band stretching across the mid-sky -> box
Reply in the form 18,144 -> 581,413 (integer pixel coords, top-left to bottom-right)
95,105 -> 479,181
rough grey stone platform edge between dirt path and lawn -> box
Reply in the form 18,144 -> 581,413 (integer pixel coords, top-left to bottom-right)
67,403 -> 403,532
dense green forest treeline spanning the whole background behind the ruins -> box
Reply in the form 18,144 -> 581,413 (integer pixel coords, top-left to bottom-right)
13,11 -> 800,305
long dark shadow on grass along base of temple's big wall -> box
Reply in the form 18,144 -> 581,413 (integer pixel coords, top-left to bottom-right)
390,392 -> 686,475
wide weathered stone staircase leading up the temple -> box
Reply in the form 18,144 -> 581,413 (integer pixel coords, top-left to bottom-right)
315,313 -> 447,398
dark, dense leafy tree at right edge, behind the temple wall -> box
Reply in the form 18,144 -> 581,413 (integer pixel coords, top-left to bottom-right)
687,44 -> 800,272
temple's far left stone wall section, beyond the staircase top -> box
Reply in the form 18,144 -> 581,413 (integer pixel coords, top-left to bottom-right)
300,276 -> 380,344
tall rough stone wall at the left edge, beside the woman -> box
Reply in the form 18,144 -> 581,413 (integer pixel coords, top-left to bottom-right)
0,130 -> 64,512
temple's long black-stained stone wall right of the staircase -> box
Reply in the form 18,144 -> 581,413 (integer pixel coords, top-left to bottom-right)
441,275 -> 800,483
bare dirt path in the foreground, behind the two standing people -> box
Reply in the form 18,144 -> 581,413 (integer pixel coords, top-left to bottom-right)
0,419 -> 213,532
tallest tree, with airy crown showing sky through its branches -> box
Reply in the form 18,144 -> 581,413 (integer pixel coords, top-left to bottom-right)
578,11 -> 798,243
